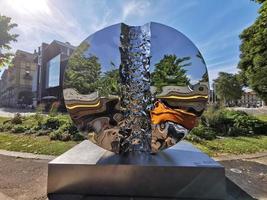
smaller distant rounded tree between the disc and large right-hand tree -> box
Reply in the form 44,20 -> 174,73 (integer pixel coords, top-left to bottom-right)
214,72 -> 242,105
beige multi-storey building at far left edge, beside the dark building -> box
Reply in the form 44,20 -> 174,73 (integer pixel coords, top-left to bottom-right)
0,50 -> 36,107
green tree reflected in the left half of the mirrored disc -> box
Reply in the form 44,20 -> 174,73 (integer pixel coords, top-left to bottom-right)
64,42 -> 101,94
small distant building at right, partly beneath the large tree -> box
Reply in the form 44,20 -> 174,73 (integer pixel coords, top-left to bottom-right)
238,91 -> 263,108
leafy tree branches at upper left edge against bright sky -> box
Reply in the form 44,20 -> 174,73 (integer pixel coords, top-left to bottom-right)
0,14 -> 18,69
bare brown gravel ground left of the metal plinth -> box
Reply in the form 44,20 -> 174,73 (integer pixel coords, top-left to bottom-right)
0,155 -> 48,200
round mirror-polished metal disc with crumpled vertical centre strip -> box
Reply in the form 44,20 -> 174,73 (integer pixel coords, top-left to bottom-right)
63,22 -> 209,153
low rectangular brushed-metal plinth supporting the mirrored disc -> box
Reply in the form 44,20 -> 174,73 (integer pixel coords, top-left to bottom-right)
47,141 -> 226,199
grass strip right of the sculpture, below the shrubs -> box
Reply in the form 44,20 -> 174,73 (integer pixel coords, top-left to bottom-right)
194,136 -> 267,156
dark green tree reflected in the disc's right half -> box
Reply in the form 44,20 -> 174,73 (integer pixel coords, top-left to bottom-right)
151,55 -> 191,90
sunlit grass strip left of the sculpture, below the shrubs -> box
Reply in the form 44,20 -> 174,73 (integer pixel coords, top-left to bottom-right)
0,133 -> 77,156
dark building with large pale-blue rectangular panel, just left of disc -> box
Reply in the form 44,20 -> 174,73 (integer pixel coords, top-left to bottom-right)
32,40 -> 75,109
